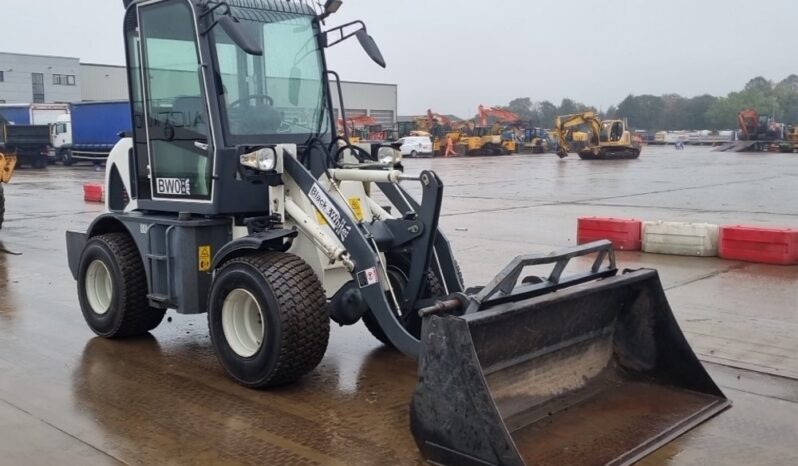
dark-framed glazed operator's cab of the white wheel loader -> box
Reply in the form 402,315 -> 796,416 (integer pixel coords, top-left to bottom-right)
122,0 -> 334,215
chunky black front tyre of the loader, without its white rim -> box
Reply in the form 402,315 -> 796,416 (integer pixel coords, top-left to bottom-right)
208,252 -> 330,388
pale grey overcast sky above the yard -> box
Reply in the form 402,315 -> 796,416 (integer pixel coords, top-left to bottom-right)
0,0 -> 798,117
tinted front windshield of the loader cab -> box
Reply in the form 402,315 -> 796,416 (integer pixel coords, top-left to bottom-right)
214,12 -> 330,144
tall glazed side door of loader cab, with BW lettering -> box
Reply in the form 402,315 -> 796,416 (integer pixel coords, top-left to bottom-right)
137,0 -> 213,203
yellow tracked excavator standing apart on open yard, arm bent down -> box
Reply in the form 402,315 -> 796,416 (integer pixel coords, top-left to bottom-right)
555,112 -> 640,160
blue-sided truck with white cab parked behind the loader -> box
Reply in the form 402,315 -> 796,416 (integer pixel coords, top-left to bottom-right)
56,101 -> 133,166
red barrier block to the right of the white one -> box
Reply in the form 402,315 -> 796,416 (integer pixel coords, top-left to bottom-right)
718,225 -> 798,265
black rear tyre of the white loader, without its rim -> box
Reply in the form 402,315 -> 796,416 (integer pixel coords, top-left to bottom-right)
78,233 -> 166,338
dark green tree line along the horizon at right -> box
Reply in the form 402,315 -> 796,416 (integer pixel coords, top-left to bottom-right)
501,74 -> 798,131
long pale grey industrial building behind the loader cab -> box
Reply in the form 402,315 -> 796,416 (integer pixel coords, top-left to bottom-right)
0,52 -> 398,126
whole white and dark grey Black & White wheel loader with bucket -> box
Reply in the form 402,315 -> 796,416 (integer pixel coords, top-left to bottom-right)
66,0 -> 729,465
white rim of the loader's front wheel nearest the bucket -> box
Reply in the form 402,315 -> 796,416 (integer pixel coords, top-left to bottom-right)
222,288 -> 266,358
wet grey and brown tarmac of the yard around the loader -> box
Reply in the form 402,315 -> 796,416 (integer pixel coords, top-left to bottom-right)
0,148 -> 798,466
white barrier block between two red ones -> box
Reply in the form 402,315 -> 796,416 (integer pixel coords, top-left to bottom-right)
642,222 -> 719,257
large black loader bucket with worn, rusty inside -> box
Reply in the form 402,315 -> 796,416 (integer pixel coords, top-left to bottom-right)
411,243 -> 730,466
